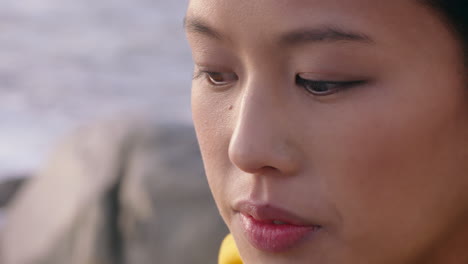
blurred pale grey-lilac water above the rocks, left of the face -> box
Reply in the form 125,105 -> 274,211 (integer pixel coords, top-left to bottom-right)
0,0 -> 192,180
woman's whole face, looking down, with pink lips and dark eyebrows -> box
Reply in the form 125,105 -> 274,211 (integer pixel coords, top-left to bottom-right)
185,0 -> 468,264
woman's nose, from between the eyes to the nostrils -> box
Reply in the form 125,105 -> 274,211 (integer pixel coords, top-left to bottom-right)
229,77 -> 299,175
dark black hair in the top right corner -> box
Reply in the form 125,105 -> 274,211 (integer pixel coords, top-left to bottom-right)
420,0 -> 468,59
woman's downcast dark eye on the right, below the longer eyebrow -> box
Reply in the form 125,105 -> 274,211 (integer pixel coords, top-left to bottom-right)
296,74 -> 365,96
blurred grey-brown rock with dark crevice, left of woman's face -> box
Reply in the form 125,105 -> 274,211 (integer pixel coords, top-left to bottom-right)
1,118 -> 227,264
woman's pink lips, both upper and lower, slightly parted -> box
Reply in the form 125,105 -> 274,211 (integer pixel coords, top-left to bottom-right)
235,202 -> 321,252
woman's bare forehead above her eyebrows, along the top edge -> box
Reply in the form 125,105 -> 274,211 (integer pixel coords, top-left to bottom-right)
187,0 -> 440,50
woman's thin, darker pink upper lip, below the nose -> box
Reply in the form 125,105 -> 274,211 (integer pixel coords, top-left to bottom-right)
234,201 -> 318,226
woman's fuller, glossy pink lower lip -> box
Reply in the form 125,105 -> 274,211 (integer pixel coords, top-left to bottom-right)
240,214 -> 320,252
